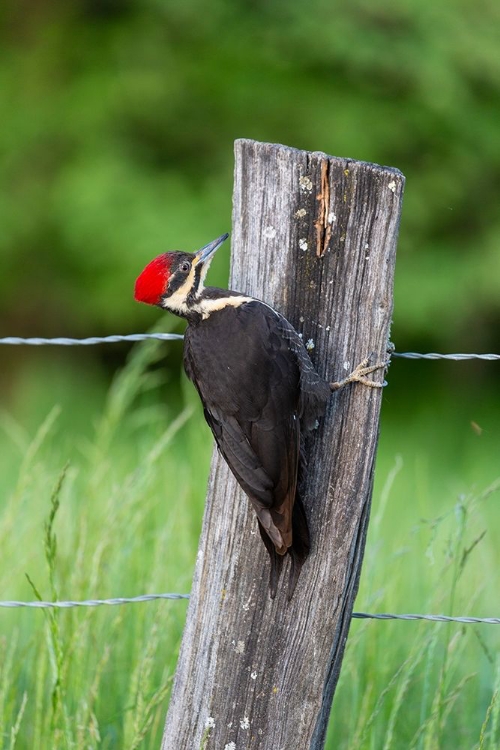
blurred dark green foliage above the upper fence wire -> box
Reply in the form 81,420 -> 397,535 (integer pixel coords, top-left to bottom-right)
0,0 -> 500,356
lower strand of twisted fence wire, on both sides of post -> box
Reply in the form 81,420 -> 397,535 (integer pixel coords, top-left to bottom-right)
0,594 -> 500,625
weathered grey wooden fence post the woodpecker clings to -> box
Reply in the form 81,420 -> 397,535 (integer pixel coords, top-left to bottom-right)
162,140 -> 404,750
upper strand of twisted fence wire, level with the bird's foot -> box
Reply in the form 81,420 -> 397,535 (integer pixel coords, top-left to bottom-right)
0,333 -> 500,362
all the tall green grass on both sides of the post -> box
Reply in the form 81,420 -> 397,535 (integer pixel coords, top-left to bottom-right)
0,342 -> 500,750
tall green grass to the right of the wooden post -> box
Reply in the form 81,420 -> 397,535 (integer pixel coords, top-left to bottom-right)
327,365 -> 500,750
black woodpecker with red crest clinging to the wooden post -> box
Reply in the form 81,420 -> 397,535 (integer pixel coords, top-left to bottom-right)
135,234 -> 380,599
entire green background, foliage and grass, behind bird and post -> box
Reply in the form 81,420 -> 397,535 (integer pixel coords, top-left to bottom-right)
0,0 -> 500,750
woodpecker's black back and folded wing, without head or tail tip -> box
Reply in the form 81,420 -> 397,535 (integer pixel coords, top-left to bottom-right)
184,302 -> 301,555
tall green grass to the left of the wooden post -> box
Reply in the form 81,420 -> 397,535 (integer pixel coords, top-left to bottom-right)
0,343 -> 206,748
